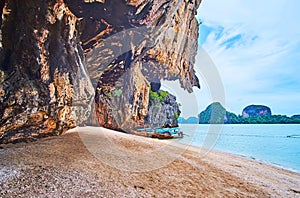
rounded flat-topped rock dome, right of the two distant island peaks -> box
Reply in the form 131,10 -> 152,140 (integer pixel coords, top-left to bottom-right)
242,105 -> 272,118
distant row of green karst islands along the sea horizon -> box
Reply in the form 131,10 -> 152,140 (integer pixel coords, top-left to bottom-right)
178,102 -> 300,124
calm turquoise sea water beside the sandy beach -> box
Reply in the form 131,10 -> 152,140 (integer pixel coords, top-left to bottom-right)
179,124 -> 300,172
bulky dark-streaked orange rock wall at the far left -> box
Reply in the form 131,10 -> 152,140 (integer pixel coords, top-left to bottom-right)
0,0 -> 94,143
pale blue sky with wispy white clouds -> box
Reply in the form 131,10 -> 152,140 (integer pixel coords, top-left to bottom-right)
195,0 -> 300,115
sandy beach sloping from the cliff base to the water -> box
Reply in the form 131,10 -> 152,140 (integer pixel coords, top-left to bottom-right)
0,127 -> 300,197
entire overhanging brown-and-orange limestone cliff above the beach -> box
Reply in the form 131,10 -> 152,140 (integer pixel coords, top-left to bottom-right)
0,0 -> 200,143
